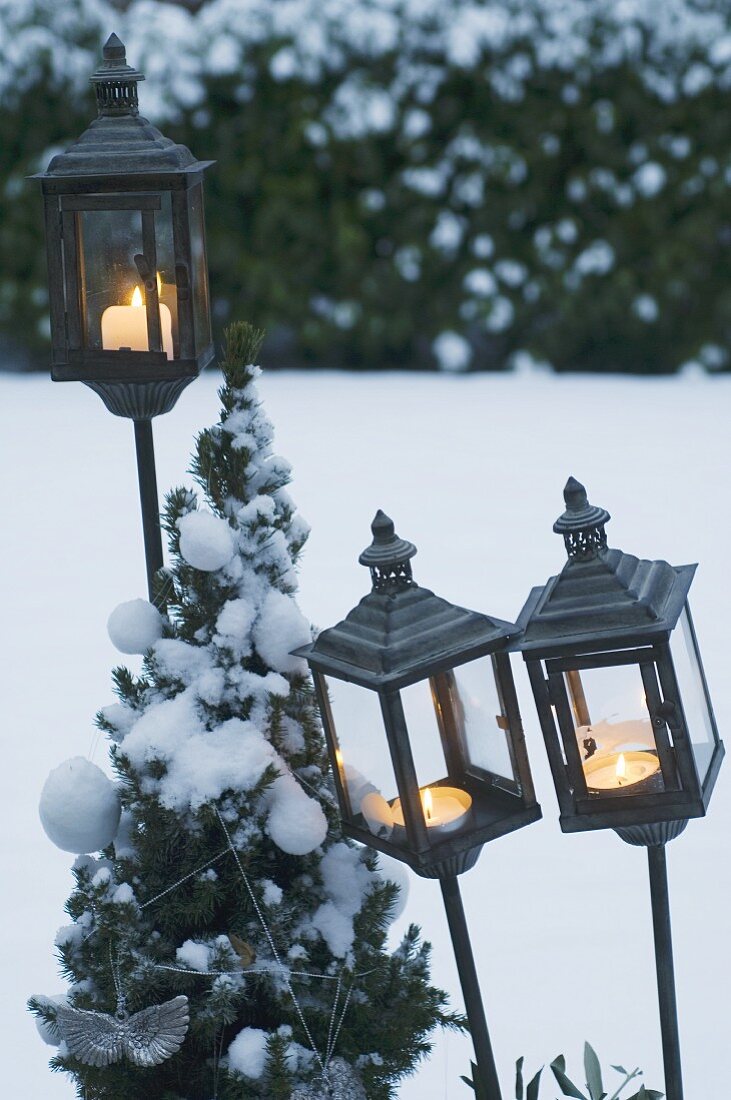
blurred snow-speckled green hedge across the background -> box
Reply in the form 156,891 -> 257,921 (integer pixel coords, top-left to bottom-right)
0,0 -> 731,373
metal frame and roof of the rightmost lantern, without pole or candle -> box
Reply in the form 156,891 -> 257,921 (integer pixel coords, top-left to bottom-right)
516,479 -> 724,844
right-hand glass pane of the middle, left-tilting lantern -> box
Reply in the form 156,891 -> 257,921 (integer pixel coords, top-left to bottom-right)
452,657 -> 516,780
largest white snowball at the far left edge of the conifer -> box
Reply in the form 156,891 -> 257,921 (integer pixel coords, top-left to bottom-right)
38,757 -> 121,856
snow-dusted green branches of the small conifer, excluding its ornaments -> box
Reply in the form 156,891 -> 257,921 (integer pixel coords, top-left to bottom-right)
31,326 -> 464,1100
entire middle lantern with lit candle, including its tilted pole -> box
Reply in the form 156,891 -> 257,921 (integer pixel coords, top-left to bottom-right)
298,512 -> 541,1100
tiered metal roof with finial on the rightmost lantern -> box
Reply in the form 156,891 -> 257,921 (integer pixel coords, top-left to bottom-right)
516,477 -> 697,652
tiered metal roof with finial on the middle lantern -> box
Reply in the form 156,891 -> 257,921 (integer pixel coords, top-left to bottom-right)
297,512 -> 517,688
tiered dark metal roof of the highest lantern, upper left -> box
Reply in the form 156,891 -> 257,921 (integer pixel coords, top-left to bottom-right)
34,34 -> 213,180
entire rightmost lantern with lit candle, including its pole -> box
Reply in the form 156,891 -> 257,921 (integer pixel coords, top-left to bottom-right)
516,477 -> 723,1100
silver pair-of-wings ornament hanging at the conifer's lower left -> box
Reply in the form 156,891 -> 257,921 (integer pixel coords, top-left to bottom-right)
56,997 -> 190,1066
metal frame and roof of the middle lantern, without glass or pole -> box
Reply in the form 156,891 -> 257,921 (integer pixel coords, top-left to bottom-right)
298,512 -> 541,878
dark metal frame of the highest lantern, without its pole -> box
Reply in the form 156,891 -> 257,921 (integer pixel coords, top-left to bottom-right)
33,34 -> 213,420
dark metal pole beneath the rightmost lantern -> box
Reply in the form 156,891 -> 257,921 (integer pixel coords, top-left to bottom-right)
647,844 -> 683,1100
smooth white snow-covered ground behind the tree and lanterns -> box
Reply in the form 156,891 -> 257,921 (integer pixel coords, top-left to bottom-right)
0,373 -> 731,1100
